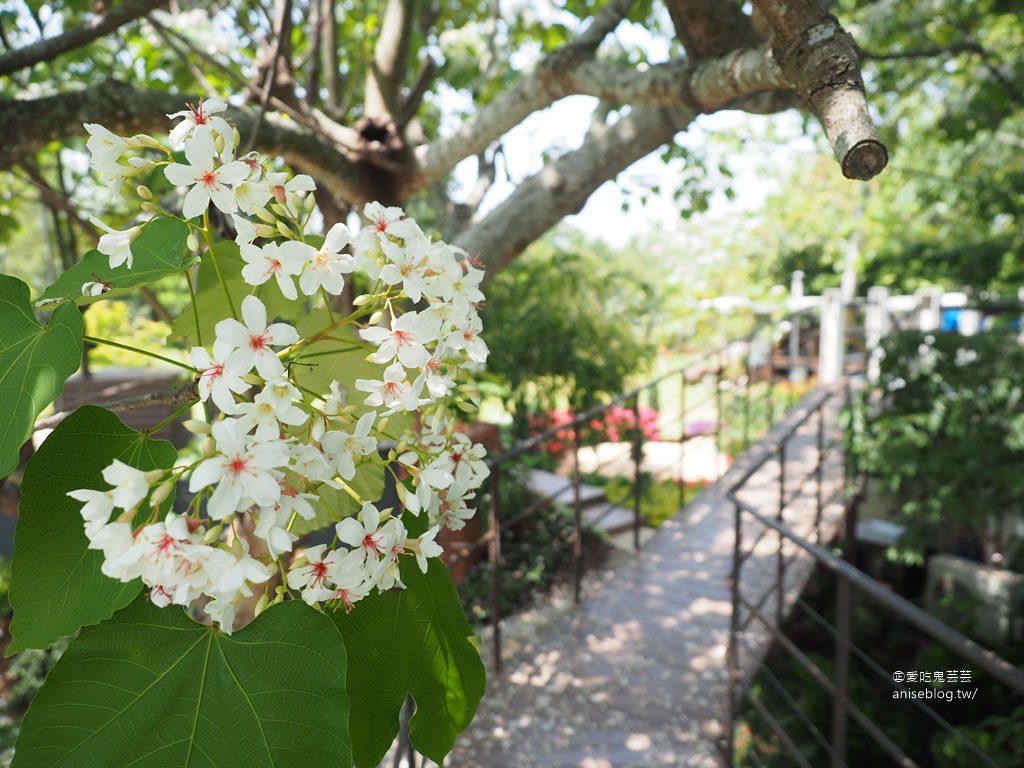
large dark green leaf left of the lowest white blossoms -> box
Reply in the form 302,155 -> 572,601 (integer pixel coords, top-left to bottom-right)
8,406 -> 177,653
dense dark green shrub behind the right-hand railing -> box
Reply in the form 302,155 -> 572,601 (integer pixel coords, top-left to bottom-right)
847,332 -> 1024,561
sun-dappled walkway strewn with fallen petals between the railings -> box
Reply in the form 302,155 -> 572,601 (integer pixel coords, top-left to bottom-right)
445,393 -> 841,768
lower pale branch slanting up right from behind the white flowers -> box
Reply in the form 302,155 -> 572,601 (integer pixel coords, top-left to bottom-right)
455,106 -> 696,276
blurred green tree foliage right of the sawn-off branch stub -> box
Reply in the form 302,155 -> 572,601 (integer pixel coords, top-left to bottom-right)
759,0 -> 1024,296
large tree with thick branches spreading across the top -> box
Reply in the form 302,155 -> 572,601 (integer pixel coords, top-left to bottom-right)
0,0 -> 887,290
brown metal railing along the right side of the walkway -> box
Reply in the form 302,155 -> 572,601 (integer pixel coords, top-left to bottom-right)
726,382 -> 1024,768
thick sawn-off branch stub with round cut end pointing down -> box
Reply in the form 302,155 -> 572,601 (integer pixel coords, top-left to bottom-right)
754,0 -> 889,181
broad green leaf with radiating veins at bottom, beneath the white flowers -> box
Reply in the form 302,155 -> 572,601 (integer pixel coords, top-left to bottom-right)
13,598 -> 352,768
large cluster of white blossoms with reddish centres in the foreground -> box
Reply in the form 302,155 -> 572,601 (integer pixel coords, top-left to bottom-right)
70,99 -> 487,632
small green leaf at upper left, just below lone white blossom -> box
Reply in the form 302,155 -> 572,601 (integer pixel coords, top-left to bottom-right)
42,218 -> 195,305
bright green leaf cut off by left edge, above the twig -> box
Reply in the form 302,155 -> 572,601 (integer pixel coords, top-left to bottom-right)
0,274 -> 84,477
